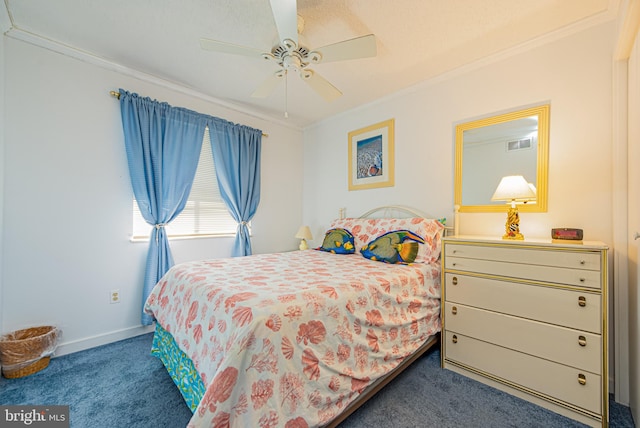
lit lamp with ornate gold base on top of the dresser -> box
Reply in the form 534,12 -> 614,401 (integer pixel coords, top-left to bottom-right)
491,175 -> 536,240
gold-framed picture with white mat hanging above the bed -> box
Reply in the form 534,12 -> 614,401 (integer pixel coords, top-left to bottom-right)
349,119 -> 394,190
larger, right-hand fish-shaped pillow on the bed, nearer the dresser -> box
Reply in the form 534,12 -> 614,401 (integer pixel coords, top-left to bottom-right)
360,230 -> 424,264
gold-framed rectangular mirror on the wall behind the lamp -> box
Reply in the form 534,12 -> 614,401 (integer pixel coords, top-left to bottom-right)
454,104 -> 549,212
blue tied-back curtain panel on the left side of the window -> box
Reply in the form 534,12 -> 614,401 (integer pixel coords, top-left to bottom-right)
120,89 -> 208,325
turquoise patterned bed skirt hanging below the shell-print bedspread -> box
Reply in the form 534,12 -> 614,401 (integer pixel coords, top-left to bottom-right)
151,323 -> 205,412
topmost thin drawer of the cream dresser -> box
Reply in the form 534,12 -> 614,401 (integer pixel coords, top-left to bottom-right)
445,244 -> 600,271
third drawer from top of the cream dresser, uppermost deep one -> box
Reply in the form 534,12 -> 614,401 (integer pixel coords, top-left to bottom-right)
444,272 -> 602,334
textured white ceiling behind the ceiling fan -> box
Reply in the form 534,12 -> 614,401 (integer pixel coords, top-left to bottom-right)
5,0 -> 618,128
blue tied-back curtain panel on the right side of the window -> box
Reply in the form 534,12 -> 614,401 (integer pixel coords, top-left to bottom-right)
207,119 -> 262,257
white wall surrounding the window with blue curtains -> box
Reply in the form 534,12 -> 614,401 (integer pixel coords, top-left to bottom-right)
0,36 -> 303,353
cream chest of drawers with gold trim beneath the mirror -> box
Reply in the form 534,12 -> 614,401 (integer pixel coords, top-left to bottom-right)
441,236 -> 609,427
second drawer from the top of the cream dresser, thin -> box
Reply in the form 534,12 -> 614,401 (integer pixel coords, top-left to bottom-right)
445,257 -> 601,289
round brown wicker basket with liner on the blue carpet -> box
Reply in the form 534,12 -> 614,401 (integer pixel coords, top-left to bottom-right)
0,326 -> 58,379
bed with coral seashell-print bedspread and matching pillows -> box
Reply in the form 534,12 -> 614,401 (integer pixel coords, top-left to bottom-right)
145,207 -> 444,428
